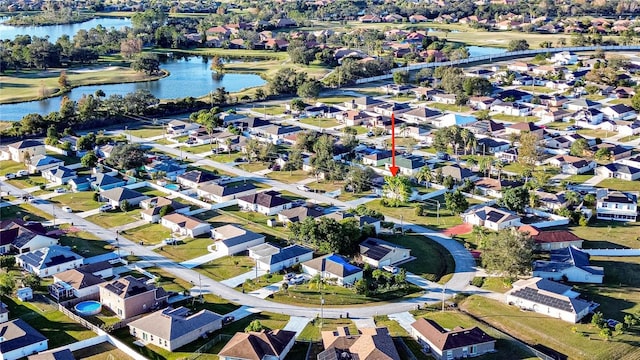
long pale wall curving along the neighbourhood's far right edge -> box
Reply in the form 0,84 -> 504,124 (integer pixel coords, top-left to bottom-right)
356,45 -> 640,84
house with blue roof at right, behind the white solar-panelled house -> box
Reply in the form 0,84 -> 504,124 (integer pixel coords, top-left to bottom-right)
533,246 -> 604,284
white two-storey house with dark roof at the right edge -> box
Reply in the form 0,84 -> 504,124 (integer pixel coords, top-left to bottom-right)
596,191 -> 638,221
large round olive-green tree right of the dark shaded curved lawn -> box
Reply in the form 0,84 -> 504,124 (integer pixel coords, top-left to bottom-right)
482,228 -> 534,278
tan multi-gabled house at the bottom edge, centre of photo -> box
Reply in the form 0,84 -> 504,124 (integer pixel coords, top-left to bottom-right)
318,326 -> 400,360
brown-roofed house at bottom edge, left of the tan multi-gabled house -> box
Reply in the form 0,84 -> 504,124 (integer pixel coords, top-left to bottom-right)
218,330 -> 296,360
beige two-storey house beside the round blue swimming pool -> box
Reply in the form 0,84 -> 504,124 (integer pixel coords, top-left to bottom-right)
100,275 -> 168,319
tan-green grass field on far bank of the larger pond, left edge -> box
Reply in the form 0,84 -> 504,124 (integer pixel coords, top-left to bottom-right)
0,66 -> 162,104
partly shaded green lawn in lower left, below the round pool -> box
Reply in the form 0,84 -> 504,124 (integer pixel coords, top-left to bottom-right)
2,295 -> 96,348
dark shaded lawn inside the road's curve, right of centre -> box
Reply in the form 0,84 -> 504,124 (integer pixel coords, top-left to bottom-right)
383,234 -> 456,281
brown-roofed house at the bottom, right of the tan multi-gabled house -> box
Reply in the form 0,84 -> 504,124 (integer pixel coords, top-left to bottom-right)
411,318 -> 496,360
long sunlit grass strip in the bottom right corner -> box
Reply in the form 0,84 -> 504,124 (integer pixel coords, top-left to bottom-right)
462,295 -> 640,360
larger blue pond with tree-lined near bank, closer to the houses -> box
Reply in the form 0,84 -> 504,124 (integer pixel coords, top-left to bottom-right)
0,56 -> 266,121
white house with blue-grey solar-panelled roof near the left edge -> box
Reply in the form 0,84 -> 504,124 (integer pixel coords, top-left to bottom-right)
16,245 -> 84,278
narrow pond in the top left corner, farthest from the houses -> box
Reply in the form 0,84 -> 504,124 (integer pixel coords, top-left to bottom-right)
0,17 -> 131,43
